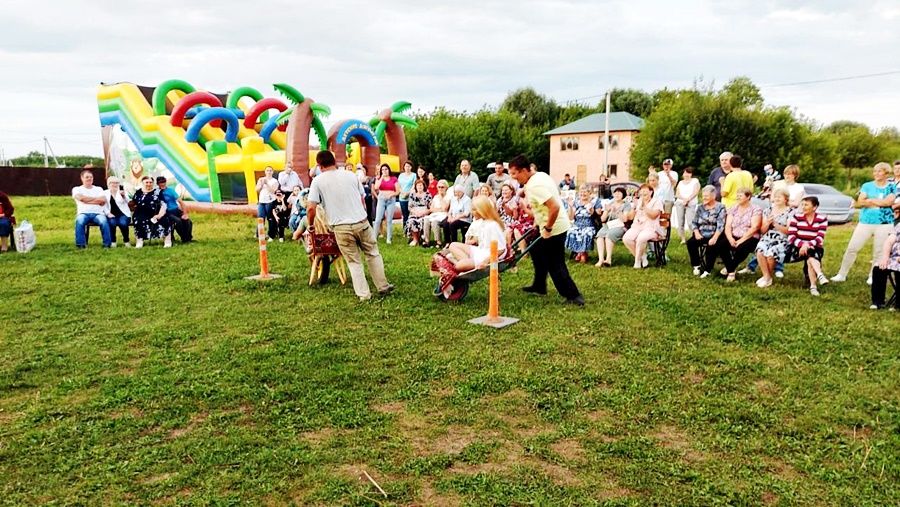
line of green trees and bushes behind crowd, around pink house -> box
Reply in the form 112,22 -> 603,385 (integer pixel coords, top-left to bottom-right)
406,77 -> 900,184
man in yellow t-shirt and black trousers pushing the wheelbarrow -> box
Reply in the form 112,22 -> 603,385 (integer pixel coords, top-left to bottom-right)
509,155 -> 584,306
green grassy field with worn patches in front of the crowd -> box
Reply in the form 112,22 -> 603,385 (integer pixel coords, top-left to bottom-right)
0,198 -> 900,505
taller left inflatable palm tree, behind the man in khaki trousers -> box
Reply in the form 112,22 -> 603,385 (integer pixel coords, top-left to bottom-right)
274,83 -> 331,187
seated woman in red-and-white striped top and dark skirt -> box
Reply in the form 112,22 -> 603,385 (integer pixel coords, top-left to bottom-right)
784,195 -> 828,296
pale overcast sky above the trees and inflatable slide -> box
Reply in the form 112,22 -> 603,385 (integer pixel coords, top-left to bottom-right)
0,0 -> 900,157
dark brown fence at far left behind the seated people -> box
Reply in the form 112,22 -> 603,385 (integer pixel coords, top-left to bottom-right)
0,166 -> 106,195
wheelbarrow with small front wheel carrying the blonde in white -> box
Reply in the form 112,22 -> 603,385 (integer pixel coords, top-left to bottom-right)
431,229 -> 541,302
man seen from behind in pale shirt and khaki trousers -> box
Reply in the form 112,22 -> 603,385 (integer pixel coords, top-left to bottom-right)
306,150 -> 394,301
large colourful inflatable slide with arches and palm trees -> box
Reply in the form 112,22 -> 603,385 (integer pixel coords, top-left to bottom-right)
97,79 -> 417,204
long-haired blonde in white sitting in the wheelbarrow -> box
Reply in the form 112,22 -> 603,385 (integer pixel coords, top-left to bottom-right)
448,195 -> 506,272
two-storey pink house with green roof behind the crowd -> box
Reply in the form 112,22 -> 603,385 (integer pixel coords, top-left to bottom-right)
544,112 -> 644,184
